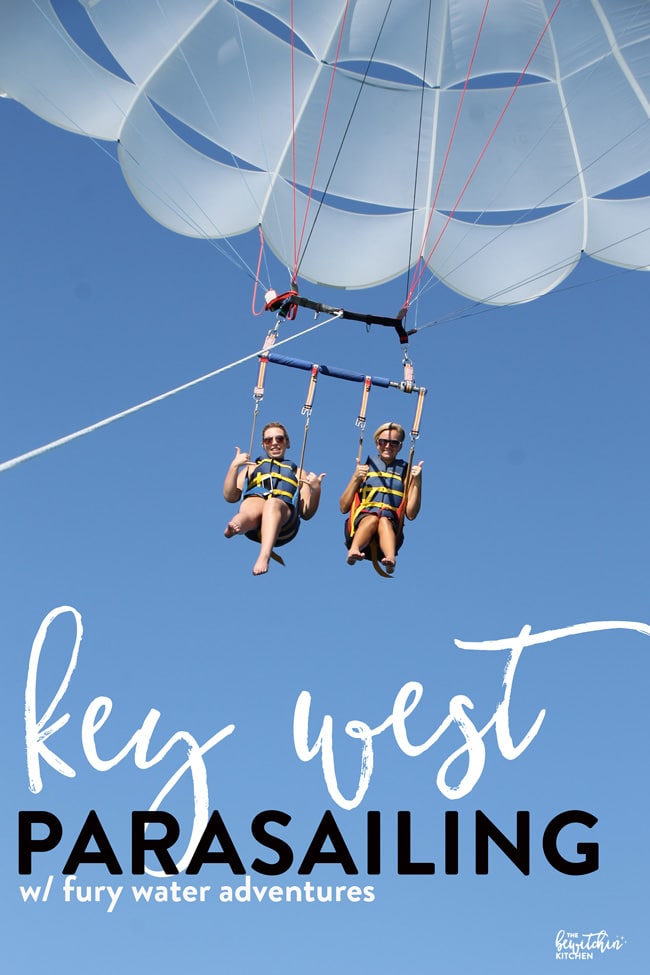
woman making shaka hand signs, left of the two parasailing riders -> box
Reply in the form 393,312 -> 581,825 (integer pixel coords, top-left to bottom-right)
223,423 -> 325,576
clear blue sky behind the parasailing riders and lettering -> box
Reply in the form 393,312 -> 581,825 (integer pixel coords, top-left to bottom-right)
0,43 -> 650,975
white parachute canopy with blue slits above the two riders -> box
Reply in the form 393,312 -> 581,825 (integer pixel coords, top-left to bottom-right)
0,0 -> 650,304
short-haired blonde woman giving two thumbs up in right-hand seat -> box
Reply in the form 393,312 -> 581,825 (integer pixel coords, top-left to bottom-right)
339,423 -> 422,572
